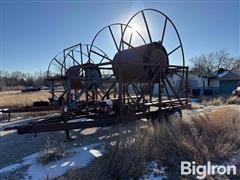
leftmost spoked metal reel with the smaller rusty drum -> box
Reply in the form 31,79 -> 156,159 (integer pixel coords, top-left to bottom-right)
47,43 -> 107,105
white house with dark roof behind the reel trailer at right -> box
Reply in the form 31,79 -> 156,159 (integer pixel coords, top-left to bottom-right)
142,68 -> 240,97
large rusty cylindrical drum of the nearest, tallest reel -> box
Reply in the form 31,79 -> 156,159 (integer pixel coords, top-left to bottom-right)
113,42 -> 169,83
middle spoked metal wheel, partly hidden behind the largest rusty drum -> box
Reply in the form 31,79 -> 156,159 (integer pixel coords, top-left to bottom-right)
90,23 -> 146,99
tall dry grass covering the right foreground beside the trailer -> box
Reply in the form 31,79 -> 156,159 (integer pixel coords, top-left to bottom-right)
59,108 -> 240,179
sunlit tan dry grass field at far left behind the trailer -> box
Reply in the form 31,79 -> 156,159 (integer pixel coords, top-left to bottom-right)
0,91 -> 51,108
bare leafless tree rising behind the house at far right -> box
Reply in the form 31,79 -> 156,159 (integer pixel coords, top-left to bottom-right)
190,50 -> 240,75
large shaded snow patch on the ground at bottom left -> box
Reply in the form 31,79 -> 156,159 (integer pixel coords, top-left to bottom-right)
0,143 -> 103,180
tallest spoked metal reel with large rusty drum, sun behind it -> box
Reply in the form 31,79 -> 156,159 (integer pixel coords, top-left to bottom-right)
116,9 -> 186,108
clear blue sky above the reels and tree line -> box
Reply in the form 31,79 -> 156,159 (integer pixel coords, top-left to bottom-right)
0,0 -> 240,72
